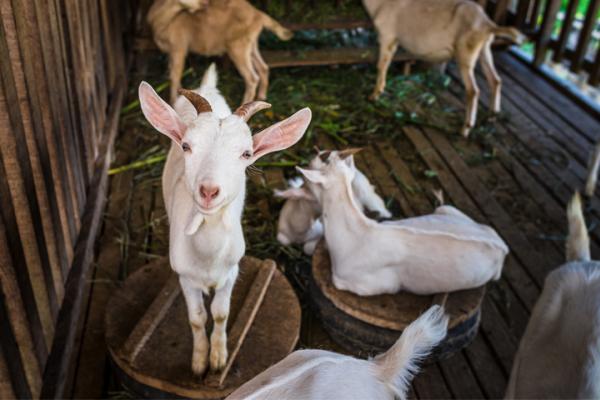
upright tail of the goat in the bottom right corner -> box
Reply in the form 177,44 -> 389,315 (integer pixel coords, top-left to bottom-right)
566,192 -> 591,261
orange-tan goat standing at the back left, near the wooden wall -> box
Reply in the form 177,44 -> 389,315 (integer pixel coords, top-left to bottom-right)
148,0 -> 292,103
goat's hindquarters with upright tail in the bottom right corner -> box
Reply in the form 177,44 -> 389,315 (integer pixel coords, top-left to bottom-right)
506,193 -> 600,399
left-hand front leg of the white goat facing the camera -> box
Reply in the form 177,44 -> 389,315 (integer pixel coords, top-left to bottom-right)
179,277 -> 208,375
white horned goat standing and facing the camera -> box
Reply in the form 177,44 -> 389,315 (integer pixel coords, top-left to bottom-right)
139,66 -> 311,374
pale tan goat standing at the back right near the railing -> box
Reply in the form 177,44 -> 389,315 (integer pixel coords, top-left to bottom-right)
363,0 -> 524,137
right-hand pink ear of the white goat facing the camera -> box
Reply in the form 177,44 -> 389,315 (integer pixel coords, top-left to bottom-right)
252,108 -> 312,162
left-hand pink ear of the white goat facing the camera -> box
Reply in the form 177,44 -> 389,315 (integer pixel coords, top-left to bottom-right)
138,82 -> 187,144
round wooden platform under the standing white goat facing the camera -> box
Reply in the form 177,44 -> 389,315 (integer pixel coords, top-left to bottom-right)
106,257 -> 301,399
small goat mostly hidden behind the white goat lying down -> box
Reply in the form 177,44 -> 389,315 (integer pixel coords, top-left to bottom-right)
274,149 -> 392,255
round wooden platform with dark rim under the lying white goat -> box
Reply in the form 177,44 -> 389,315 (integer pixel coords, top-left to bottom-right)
310,240 -> 485,361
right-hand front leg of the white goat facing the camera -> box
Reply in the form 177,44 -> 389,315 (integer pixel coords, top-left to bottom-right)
210,265 -> 239,371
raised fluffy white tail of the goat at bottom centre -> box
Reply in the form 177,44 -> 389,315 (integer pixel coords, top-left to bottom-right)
374,305 -> 448,399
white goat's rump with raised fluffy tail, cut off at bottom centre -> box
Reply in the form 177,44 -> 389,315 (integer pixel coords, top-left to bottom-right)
227,306 -> 448,400
